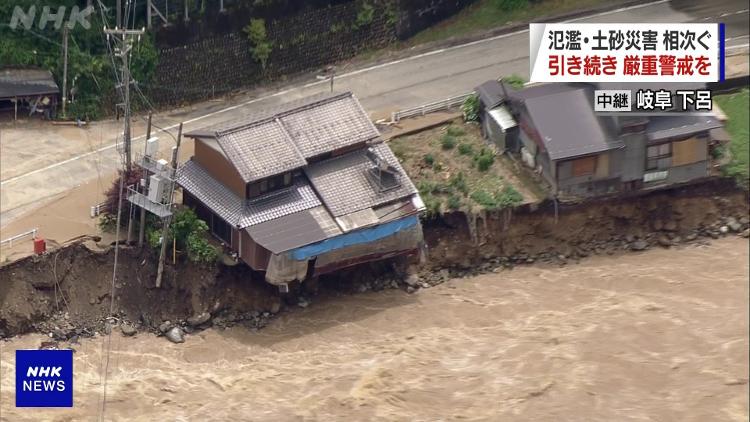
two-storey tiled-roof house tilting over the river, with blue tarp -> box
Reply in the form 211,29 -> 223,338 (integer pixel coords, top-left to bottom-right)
177,93 -> 424,285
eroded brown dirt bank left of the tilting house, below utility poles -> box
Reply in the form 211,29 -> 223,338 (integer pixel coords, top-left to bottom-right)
0,243 -> 279,337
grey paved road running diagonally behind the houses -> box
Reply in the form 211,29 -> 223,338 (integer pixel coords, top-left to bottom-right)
0,0 -> 748,227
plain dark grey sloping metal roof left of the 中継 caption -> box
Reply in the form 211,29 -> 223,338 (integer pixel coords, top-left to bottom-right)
525,88 -> 618,160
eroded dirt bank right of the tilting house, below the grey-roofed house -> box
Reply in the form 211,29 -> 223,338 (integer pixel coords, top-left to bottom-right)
425,181 -> 748,269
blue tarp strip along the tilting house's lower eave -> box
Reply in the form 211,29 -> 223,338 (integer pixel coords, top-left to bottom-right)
289,215 -> 419,261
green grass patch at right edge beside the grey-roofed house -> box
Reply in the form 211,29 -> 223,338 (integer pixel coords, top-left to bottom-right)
715,88 -> 750,188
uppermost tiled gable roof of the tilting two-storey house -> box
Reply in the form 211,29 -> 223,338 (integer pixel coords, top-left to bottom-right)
186,92 -> 379,182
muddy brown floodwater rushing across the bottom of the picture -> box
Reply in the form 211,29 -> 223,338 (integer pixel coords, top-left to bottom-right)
0,238 -> 749,421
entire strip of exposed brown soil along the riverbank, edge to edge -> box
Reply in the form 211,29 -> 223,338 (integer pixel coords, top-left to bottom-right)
0,181 -> 748,340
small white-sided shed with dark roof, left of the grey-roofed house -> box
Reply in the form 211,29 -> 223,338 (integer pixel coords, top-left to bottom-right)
476,80 -> 517,152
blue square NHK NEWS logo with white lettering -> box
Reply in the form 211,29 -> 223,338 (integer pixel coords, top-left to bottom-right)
16,350 -> 73,407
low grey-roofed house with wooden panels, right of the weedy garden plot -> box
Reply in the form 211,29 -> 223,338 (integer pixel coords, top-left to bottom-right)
476,83 -> 722,197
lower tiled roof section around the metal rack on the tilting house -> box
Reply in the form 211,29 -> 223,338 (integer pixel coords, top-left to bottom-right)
305,143 -> 417,217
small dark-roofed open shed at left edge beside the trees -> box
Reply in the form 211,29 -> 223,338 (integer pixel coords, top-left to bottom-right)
0,68 -> 60,119
